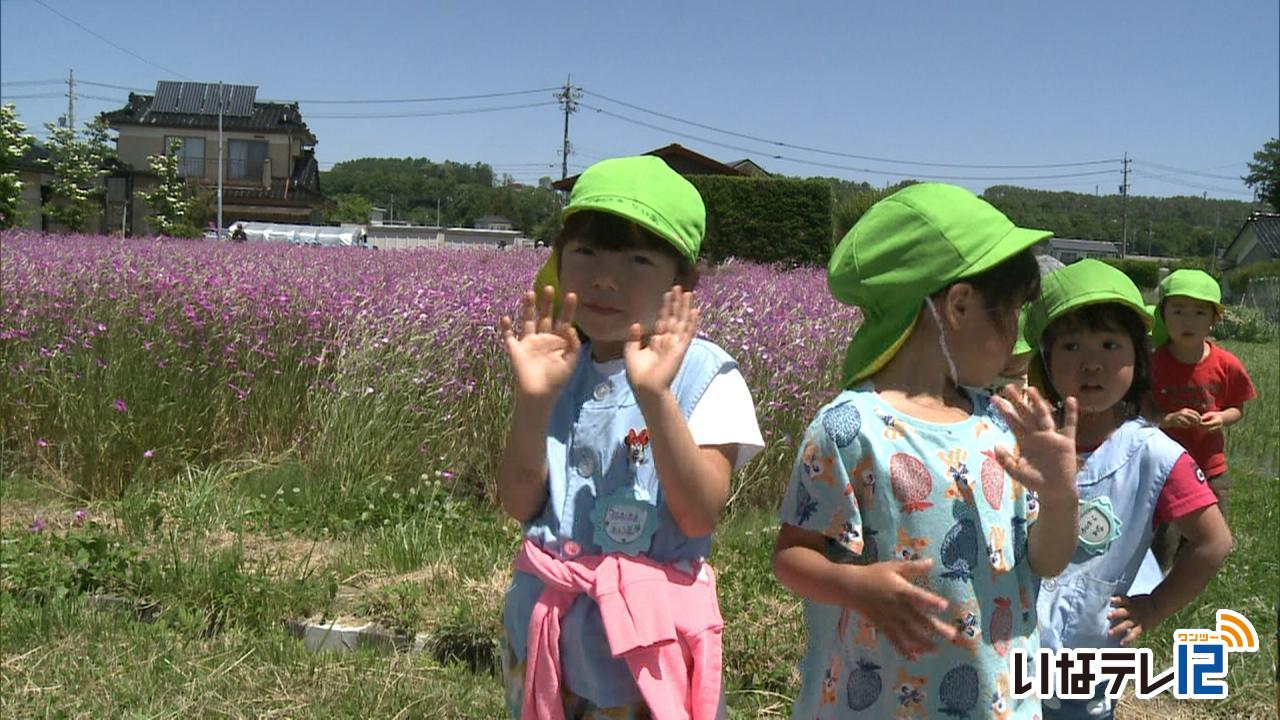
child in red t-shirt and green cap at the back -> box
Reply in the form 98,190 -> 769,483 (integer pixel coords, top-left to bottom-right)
1151,270 -> 1257,569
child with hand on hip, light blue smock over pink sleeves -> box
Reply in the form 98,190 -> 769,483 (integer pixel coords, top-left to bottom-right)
1027,260 -> 1231,719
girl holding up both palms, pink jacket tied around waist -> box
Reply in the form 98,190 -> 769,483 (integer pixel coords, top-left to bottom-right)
498,156 -> 763,719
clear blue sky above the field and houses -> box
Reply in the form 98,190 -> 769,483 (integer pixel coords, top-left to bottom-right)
0,0 -> 1280,200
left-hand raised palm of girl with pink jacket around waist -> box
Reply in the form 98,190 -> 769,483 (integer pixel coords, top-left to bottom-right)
499,286 -> 582,400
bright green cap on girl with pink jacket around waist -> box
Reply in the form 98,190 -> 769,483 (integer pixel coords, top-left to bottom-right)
534,155 -> 707,299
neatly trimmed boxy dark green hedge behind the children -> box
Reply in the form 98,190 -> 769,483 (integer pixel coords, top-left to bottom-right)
689,176 -> 832,265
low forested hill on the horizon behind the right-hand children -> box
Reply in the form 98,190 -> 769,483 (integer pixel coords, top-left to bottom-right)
983,184 -> 1254,258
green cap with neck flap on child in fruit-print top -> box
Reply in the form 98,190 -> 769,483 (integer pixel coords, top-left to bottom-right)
827,183 -> 1052,386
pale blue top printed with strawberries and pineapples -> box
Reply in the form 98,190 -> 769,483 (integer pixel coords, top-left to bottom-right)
780,383 -> 1041,720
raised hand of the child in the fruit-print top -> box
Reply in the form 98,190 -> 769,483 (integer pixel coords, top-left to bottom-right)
992,386 -> 1079,502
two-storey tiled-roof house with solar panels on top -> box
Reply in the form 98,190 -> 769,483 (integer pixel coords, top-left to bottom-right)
102,81 -> 324,234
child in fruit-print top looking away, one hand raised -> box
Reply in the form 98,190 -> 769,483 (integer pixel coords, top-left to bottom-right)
773,183 -> 1076,720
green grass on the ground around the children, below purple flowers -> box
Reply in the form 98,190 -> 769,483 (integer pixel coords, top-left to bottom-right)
0,342 -> 1280,717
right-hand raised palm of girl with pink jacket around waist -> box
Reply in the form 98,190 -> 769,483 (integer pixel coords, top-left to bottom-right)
622,284 -> 698,395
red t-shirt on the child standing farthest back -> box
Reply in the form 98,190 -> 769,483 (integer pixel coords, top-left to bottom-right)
1151,342 -> 1258,478
